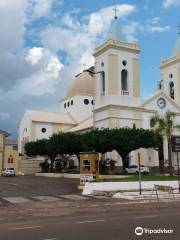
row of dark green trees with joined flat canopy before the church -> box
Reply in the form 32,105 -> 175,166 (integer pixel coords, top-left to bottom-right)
25,128 -> 161,173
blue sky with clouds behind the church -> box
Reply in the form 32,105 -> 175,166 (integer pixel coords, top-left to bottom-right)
0,0 -> 180,138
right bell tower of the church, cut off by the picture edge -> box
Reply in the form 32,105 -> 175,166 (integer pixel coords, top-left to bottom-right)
160,26 -> 180,106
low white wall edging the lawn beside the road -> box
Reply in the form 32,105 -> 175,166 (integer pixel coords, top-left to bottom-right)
82,181 -> 178,195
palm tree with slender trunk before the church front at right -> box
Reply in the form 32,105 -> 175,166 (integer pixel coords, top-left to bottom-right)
150,110 -> 180,176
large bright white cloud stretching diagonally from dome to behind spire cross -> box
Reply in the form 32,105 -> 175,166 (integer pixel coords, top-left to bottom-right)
42,4 -> 136,73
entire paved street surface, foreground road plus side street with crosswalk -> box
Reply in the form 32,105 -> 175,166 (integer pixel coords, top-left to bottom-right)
0,176 -> 180,240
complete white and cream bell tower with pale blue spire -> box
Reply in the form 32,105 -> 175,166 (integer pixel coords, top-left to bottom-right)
94,12 -> 141,127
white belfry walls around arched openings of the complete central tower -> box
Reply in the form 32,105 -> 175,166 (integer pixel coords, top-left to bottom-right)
95,44 -> 140,108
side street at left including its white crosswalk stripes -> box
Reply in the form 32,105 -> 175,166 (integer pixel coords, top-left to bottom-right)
0,176 -> 111,205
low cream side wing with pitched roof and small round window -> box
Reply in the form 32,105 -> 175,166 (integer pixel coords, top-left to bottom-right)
18,110 -> 77,154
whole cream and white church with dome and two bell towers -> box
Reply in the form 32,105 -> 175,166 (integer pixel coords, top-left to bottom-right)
19,16 -> 180,172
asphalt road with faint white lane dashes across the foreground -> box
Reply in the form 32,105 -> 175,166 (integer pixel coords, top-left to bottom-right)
0,201 -> 180,240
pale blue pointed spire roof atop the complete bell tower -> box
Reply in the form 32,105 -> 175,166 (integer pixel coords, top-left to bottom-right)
108,17 -> 127,42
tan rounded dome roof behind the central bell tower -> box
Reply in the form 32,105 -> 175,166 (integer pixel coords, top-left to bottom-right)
65,70 -> 94,99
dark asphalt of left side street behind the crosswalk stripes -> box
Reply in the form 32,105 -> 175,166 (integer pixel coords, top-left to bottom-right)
0,175 -> 79,197
